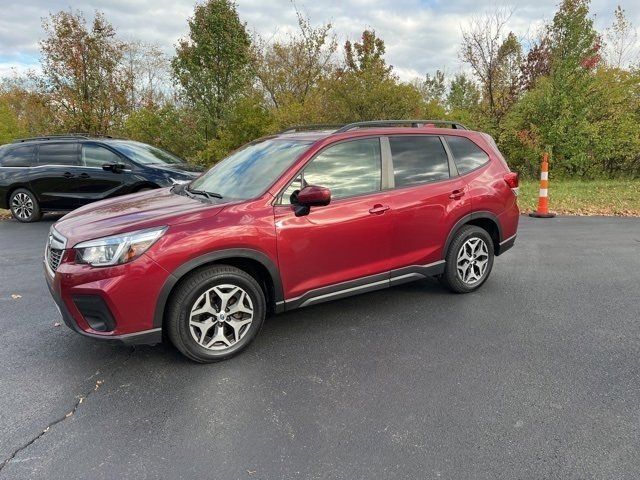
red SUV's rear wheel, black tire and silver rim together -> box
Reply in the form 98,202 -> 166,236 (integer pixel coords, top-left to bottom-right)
440,225 -> 494,293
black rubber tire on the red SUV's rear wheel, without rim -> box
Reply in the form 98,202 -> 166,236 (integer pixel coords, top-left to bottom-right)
439,225 -> 494,293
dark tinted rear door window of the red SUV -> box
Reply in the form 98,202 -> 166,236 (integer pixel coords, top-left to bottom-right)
389,135 -> 449,187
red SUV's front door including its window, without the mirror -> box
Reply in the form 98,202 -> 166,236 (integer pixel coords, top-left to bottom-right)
274,138 -> 391,306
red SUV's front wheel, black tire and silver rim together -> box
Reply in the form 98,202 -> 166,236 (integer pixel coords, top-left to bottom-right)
167,265 -> 266,363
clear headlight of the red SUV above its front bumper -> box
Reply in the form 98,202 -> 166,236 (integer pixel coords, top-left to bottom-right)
74,227 -> 167,267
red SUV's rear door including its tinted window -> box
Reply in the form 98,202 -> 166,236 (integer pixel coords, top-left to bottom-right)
387,134 -> 471,279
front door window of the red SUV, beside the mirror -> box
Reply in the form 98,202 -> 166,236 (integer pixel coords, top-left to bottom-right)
282,138 -> 382,203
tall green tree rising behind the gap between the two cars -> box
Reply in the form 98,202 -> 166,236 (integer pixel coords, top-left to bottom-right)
171,0 -> 251,139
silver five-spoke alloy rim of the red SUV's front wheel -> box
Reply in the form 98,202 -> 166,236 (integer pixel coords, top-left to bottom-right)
189,284 -> 254,351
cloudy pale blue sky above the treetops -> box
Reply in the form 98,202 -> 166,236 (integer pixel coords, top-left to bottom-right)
0,0 -> 640,79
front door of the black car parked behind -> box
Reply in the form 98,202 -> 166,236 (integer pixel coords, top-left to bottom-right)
76,142 -> 132,206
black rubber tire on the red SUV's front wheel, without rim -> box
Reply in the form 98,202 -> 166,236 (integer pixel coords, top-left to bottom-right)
165,265 -> 266,363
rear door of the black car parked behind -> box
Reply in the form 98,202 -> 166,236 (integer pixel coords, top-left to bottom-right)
30,142 -> 80,210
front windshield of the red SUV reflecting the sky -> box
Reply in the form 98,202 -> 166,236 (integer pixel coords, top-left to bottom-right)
189,139 -> 310,200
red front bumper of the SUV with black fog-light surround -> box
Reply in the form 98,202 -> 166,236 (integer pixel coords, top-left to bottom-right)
43,252 -> 169,345
